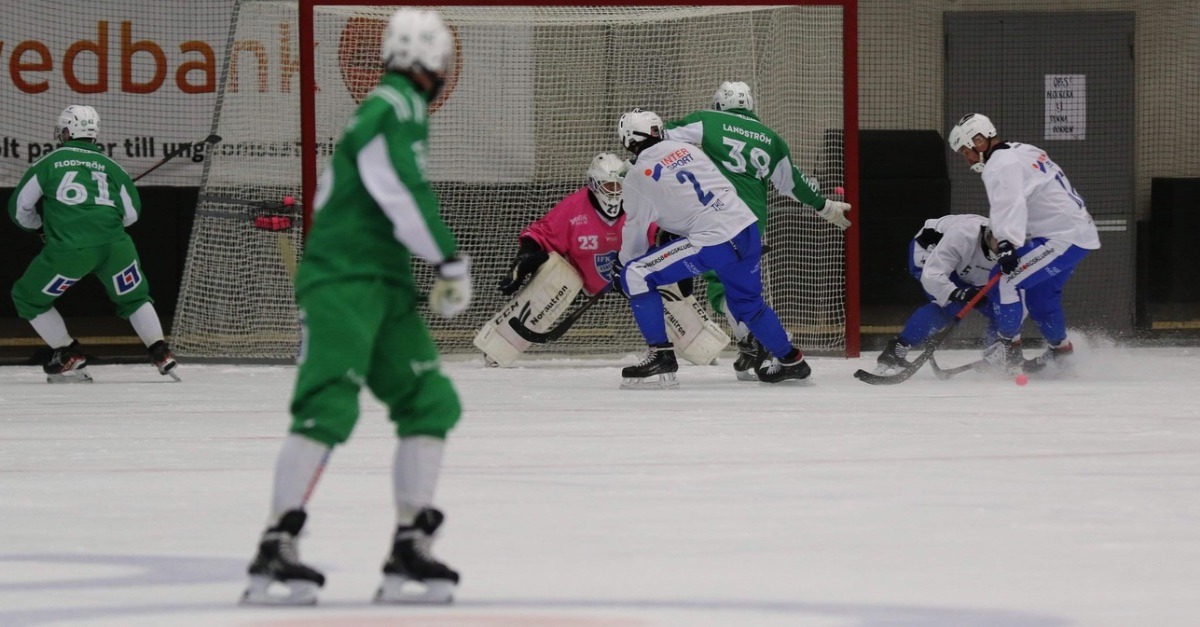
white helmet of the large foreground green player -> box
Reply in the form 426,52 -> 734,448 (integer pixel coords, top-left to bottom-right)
379,8 -> 454,74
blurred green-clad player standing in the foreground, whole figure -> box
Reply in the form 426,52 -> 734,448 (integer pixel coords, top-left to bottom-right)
242,10 -> 472,604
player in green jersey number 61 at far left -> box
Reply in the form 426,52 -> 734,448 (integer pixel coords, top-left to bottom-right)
8,105 -> 179,383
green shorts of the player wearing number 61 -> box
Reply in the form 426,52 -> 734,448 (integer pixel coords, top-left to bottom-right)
12,235 -> 154,320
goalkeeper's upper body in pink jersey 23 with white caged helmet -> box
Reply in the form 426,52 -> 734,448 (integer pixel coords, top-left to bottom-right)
500,153 -> 656,295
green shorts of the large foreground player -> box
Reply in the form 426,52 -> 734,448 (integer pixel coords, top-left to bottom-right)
292,280 -> 462,446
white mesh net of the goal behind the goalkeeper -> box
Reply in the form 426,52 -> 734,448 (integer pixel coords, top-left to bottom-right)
174,0 -> 857,358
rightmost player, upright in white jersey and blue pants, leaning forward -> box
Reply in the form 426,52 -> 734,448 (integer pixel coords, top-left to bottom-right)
949,113 -> 1100,371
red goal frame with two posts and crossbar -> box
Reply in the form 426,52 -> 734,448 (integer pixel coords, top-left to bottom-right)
299,0 -> 863,358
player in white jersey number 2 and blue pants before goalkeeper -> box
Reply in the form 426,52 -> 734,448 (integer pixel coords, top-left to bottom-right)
613,109 -> 811,388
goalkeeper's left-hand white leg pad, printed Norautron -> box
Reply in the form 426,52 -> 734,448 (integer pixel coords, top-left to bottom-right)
473,252 -> 583,366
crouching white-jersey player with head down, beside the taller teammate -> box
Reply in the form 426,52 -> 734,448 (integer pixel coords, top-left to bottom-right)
876,214 -> 996,375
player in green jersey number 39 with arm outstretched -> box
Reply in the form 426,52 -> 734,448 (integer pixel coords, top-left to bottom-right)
666,82 -> 850,381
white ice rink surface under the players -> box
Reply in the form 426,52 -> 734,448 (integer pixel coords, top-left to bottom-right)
0,338 -> 1200,627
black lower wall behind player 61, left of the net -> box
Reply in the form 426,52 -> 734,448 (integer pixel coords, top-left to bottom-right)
0,187 -> 199,324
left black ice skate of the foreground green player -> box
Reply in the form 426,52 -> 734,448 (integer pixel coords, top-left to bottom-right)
241,509 -> 325,605
